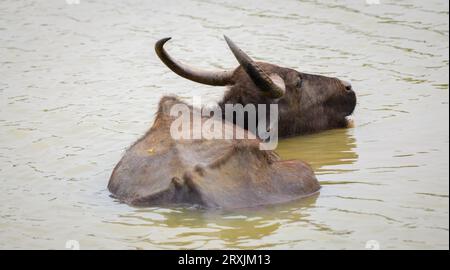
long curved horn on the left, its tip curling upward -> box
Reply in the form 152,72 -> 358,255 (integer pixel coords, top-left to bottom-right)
155,37 -> 233,86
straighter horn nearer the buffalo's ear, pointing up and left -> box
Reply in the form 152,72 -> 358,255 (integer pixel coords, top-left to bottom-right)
224,36 -> 285,98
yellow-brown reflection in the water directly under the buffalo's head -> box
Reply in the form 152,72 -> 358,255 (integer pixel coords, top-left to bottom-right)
276,129 -> 358,174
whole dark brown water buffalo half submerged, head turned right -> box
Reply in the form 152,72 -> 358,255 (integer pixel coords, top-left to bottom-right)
108,37 -> 356,209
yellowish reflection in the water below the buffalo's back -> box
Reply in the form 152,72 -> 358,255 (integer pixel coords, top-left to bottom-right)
110,194 -> 320,248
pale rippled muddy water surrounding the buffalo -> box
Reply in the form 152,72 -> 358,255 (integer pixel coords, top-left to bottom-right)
0,0 -> 449,249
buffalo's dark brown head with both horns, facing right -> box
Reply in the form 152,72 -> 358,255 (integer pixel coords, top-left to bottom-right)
155,36 -> 356,137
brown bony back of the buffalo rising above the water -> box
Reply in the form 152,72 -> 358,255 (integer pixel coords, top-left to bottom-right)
108,97 -> 320,208
